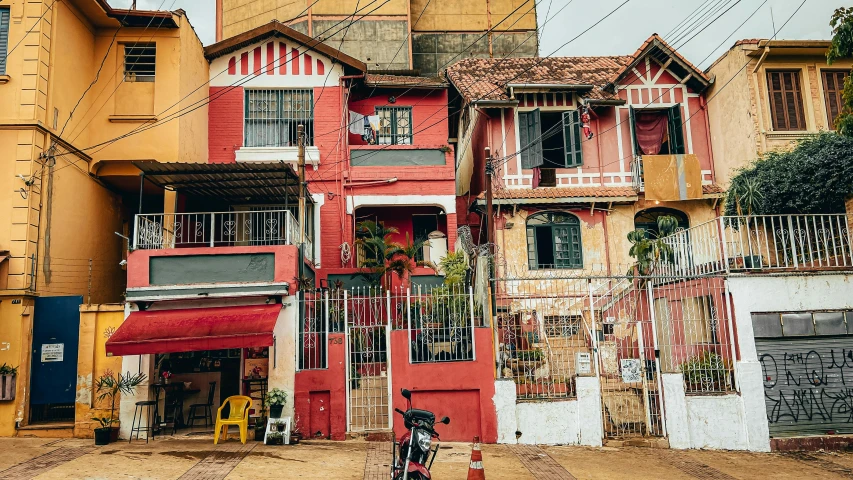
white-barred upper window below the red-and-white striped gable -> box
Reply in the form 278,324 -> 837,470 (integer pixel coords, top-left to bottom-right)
244,89 -> 314,147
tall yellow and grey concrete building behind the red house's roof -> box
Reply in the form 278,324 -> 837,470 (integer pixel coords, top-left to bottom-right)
216,0 -> 539,75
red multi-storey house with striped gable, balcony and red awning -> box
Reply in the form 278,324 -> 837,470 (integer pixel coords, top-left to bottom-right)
108,22 -> 496,441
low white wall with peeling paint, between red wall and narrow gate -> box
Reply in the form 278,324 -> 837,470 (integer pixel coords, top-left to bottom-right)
494,377 -> 604,447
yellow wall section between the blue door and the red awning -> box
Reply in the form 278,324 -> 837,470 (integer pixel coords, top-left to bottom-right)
74,304 -> 125,438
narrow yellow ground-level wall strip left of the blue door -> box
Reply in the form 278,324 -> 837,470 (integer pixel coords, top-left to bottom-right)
0,295 -> 33,437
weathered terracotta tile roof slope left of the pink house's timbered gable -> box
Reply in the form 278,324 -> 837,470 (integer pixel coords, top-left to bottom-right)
447,56 -> 633,101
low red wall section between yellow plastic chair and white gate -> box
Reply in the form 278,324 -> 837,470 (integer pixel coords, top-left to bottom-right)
294,333 -> 347,440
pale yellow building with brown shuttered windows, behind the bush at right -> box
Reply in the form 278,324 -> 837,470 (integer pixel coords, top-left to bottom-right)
708,40 -> 853,186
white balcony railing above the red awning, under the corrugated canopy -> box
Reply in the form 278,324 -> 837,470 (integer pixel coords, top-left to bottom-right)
133,210 -> 314,259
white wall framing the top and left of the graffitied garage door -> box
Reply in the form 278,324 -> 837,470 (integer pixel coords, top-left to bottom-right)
728,274 -> 853,451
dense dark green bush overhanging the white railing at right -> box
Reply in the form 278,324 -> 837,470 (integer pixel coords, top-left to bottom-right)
725,133 -> 853,216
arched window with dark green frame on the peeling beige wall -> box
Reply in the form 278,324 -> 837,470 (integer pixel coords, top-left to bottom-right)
527,212 -> 583,270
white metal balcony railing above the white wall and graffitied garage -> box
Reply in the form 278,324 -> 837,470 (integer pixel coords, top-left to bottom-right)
659,214 -> 853,275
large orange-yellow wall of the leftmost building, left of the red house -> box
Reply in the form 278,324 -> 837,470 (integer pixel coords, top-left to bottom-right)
0,0 -> 208,436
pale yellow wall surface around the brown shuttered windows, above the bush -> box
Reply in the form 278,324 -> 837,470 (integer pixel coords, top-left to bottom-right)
707,45 -> 853,187
